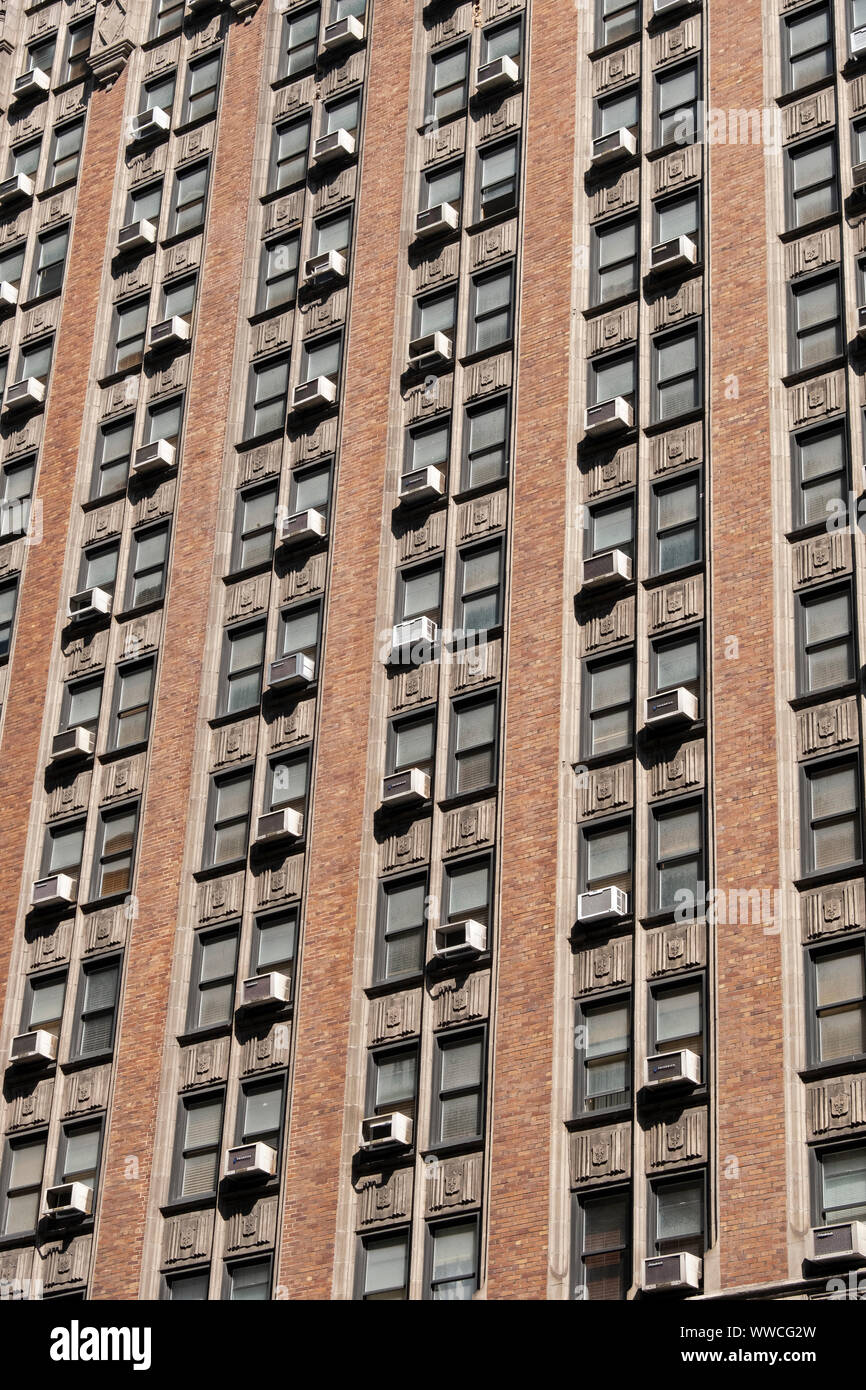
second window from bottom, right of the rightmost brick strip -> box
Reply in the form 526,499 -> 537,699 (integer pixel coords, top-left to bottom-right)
806,938 -> 866,1066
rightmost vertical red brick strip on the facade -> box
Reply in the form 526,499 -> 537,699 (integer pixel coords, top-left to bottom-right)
708,0 -> 788,1286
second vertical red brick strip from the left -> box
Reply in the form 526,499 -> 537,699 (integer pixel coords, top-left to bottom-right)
93,15 -> 265,1298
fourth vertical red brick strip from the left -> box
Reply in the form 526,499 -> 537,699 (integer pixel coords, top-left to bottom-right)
488,0 -> 577,1298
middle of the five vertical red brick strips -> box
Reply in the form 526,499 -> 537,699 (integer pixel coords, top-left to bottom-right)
279,0 -> 413,1298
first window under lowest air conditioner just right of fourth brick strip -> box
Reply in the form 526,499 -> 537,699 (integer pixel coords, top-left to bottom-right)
574,995 -> 631,1115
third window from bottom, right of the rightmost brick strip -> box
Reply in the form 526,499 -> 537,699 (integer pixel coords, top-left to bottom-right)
801,759 -> 862,873
